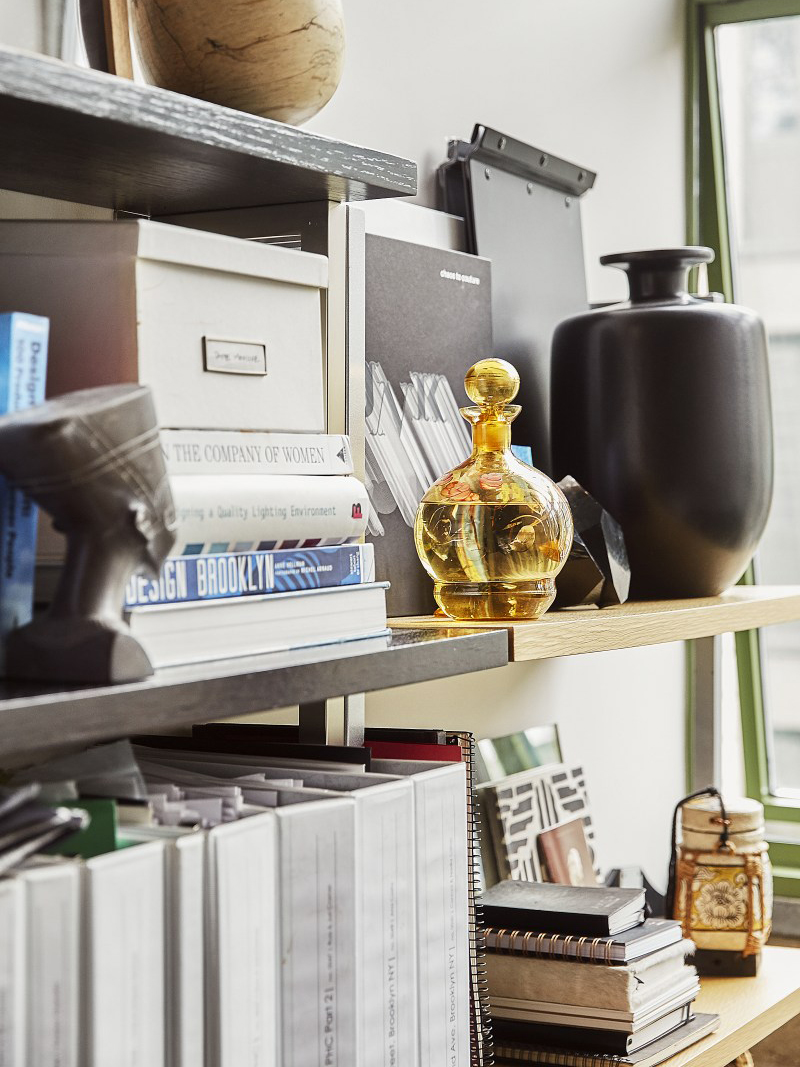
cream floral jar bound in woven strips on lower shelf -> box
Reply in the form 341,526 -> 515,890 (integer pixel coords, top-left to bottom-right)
673,795 -> 772,956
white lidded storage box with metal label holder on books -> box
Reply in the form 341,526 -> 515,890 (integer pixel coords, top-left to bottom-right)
0,220 -> 327,432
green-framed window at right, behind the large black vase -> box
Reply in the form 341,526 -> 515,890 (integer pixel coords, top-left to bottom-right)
686,0 -> 800,896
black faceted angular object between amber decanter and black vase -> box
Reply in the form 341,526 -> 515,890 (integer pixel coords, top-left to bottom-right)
553,475 -> 630,608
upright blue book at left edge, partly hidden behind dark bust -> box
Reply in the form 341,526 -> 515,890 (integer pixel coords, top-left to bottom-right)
0,312 -> 49,641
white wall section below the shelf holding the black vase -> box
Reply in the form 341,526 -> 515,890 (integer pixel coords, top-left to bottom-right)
367,644 -> 685,888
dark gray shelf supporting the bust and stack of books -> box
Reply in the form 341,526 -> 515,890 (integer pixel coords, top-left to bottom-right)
0,626 -> 509,765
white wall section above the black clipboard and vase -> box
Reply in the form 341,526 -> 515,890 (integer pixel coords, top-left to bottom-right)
308,0 -> 684,301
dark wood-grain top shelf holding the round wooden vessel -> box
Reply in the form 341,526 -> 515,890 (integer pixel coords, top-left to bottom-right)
0,47 -> 417,216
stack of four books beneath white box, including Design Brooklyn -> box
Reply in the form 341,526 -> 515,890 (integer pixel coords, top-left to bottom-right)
117,430 -> 388,667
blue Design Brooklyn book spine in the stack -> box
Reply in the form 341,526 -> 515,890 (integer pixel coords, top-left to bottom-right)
125,544 -> 374,610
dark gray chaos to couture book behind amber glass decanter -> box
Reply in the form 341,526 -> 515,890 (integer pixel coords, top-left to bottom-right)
365,234 -> 494,617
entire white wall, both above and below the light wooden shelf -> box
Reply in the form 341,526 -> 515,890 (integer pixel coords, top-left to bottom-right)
309,0 -> 684,883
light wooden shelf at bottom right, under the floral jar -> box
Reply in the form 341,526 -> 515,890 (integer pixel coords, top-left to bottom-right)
662,947 -> 800,1067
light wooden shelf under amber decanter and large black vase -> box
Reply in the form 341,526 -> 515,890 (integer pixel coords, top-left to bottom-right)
389,586 -> 800,662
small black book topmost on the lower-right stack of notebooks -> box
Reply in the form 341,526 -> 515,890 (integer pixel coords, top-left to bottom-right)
482,881 -> 644,937
